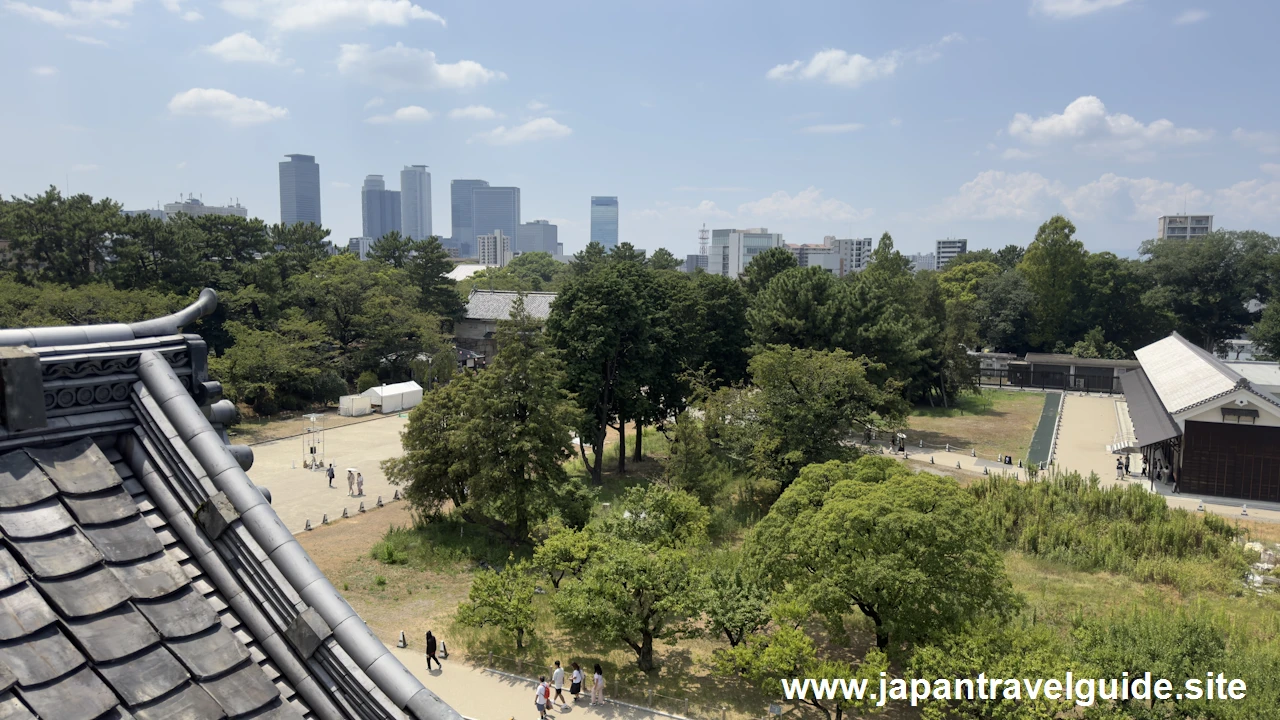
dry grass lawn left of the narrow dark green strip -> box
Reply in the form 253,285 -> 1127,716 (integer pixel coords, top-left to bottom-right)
906,389 -> 1044,459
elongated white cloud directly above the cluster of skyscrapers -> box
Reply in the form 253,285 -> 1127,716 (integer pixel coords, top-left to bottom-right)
338,42 -> 507,90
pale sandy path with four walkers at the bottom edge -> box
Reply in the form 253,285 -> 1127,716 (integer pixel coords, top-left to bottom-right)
392,647 -> 669,720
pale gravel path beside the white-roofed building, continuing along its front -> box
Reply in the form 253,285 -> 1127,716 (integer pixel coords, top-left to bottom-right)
1053,393 -> 1280,523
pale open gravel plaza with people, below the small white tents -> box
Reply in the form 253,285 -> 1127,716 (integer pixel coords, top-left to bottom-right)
248,415 -> 408,533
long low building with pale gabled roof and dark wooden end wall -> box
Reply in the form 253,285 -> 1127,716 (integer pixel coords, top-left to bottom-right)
1120,333 -> 1280,502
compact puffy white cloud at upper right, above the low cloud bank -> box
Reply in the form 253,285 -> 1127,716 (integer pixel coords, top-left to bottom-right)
1007,95 -> 1213,159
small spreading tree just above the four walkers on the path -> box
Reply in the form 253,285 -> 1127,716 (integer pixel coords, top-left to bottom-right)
552,538 -> 703,671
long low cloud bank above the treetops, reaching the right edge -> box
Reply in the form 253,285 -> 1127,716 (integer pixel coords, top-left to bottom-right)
931,170 -> 1280,224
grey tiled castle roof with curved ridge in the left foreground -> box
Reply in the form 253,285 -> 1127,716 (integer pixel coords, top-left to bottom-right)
0,288 -> 460,720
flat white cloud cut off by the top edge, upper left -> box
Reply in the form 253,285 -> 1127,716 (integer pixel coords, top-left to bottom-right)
221,0 -> 444,32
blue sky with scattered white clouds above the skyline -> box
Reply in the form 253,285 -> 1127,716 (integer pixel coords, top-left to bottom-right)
0,0 -> 1280,255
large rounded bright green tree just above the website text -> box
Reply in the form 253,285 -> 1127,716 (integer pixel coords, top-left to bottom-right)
746,473 -> 1019,648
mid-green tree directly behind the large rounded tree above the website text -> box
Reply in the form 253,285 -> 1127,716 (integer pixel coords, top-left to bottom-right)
750,346 -> 906,487
